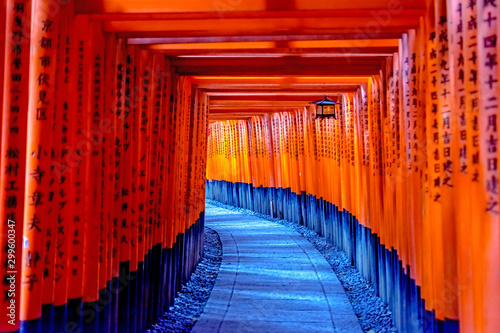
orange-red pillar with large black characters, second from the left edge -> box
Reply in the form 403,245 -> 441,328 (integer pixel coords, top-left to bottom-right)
20,0 -> 59,320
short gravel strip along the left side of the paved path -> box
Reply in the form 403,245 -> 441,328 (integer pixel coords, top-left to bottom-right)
146,227 -> 222,333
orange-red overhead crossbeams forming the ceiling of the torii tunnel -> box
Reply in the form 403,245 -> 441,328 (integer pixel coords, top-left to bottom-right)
76,0 -> 427,120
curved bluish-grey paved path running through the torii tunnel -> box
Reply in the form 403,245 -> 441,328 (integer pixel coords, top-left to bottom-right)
192,204 -> 362,333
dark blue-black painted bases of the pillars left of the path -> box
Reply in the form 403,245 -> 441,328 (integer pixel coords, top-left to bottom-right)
20,214 -> 205,333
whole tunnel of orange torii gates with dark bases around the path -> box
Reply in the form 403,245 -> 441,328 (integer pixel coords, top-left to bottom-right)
0,0 -> 500,332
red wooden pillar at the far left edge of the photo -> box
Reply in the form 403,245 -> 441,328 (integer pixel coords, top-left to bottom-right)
0,0 -> 31,331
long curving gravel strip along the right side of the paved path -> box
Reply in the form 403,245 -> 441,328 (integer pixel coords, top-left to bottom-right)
206,199 -> 397,333
